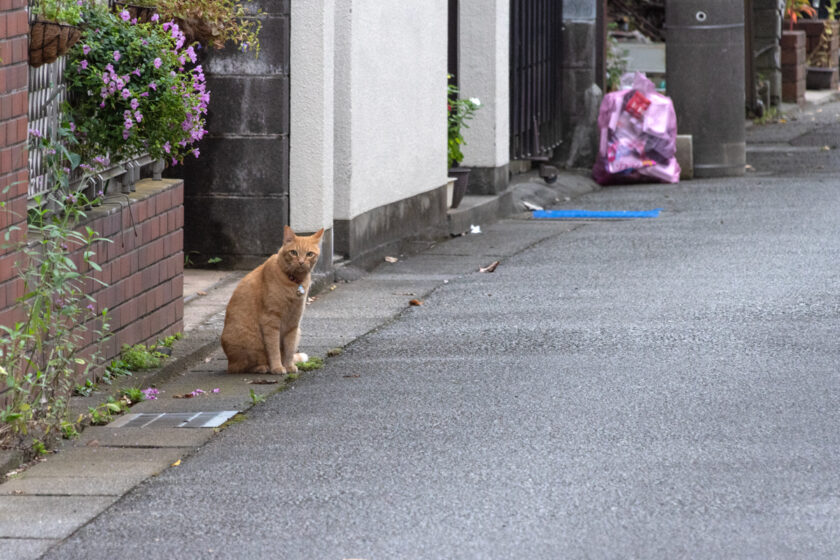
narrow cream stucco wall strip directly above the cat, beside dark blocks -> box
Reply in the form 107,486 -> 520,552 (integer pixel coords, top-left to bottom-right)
289,0 -> 335,232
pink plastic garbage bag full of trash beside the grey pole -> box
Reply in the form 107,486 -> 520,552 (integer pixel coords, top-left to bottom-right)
592,72 -> 680,185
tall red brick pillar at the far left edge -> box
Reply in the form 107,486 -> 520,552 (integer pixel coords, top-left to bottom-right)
0,0 -> 29,324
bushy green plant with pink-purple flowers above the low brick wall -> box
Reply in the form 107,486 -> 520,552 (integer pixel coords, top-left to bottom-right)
65,7 -> 210,167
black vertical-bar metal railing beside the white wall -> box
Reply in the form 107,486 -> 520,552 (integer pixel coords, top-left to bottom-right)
510,0 -> 563,159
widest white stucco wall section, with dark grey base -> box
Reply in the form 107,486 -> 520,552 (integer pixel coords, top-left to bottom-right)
334,0 -> 447,223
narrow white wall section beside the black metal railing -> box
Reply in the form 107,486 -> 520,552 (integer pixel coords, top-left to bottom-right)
457,0 -> 510,167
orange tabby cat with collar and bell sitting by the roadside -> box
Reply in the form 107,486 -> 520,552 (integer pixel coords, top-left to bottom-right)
222,226 -> 324,374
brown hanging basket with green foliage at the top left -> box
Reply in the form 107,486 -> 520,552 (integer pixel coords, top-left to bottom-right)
29,0 -> 84,68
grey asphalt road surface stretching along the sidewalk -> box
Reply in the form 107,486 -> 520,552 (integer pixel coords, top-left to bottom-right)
47,108 -> 840,560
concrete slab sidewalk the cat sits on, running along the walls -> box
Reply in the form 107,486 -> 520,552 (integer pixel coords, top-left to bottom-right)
0,173 -> 597,559
